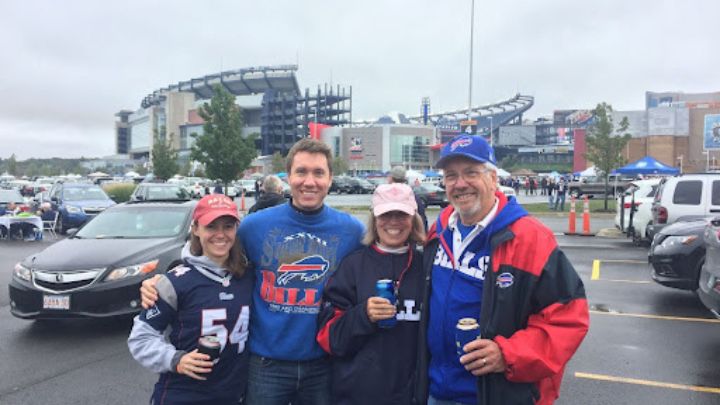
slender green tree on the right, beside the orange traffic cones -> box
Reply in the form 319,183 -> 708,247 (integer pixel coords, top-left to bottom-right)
585,102 -> 630,211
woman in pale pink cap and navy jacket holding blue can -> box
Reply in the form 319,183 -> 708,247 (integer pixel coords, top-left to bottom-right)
317,183 -> 425,405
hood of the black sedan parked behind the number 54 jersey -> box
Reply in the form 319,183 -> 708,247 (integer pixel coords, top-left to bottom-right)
25,238 -> 180,270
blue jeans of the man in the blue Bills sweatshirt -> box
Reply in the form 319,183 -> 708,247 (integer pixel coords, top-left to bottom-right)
245,354 -> 330,405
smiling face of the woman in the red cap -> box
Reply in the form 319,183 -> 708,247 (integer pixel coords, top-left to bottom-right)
192,216 -> 238,266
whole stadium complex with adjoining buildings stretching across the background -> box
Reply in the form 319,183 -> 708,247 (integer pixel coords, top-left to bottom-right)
115,65 -> 720,172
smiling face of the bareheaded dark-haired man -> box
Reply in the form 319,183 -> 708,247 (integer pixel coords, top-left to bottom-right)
288,151 -> 332,211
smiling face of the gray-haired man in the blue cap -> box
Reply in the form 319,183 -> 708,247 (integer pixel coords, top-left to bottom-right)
443,157 -> 497,225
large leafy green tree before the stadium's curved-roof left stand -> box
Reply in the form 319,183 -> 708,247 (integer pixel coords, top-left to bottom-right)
190,85 -> 256,193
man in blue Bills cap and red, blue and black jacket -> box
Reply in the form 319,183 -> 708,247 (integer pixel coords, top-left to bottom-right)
416,135 -> 589,405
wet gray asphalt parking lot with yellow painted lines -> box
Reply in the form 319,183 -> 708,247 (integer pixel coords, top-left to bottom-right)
0,196 -> 720,405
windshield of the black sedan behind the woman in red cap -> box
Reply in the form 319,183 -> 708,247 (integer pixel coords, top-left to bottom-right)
75,206 -> 190,239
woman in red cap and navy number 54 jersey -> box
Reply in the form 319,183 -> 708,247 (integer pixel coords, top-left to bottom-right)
128,194 -> 254,404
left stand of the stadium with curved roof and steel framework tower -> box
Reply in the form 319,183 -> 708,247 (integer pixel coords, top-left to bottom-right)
115,65 -> 352,159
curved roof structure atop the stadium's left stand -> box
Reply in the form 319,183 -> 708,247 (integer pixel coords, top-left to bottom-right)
141,65 -> 300,108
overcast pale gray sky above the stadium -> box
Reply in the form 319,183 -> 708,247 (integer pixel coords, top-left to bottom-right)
0,0 -> 720,159
